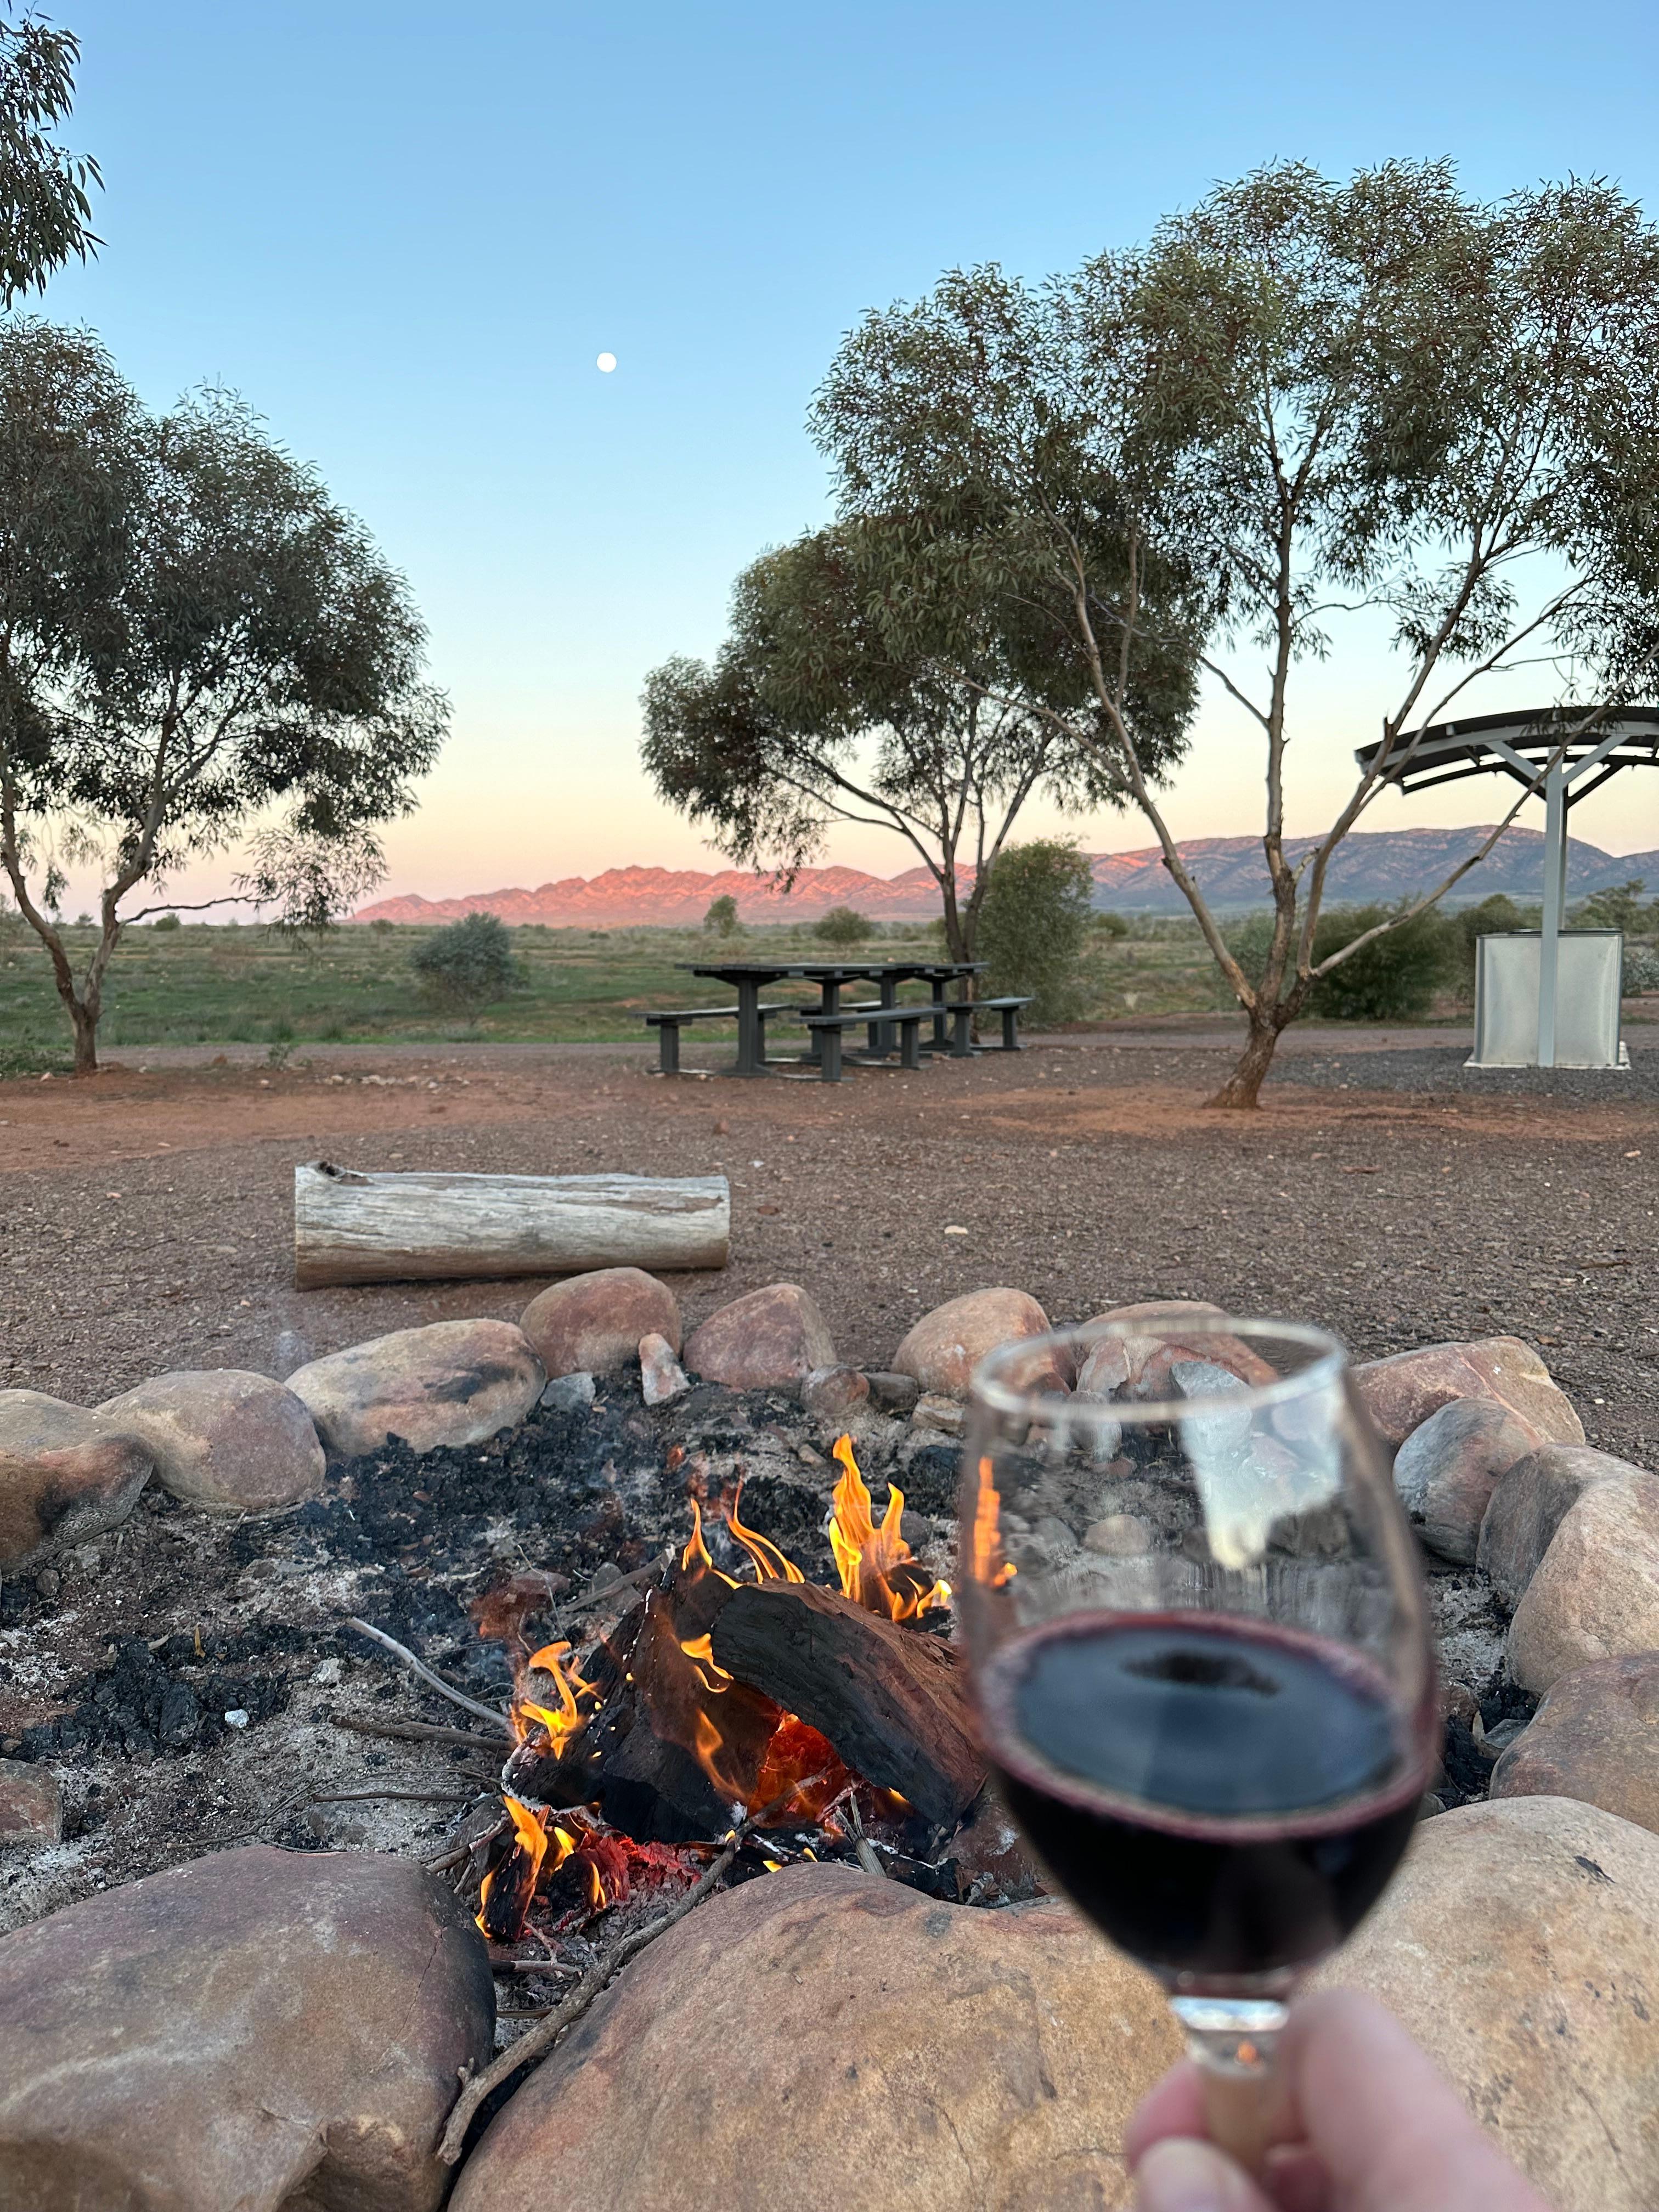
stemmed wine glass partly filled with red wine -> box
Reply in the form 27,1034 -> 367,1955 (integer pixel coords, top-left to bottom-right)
958,1312 -> 1440,2170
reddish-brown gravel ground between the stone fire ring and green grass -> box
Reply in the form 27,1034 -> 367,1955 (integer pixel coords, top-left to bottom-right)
0,1035 -> 1659,1458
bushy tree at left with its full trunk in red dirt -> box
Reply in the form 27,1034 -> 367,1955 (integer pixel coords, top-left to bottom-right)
0,336 -> 447,1073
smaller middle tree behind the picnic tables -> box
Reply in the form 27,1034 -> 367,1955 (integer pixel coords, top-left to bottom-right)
641,515 -> 1192,960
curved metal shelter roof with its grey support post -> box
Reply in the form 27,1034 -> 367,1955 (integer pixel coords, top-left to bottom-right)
1354,706 -> 1659,1068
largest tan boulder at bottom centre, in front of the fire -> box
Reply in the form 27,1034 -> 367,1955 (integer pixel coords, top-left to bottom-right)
452,1867 -> 1179,2212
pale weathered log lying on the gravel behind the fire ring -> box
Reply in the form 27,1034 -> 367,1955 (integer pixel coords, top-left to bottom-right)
294,1159 -> 732,1290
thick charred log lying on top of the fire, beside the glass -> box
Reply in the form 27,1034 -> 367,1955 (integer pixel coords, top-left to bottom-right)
712,1582 -> 984,1827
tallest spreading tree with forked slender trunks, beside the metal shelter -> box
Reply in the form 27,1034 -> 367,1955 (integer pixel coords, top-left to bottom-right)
814,163 -> 1659,1106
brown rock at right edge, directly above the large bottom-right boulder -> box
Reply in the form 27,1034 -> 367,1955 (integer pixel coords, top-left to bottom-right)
1491,1652 -> 1659,1834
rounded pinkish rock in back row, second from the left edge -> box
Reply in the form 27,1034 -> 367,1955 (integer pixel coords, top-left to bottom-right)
97,1367 -> 328,1513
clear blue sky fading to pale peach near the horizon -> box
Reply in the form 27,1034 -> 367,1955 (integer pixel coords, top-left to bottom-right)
47,0 -> 1659,894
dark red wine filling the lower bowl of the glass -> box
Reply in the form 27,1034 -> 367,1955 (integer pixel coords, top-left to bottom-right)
980,1612 -> 1425,1980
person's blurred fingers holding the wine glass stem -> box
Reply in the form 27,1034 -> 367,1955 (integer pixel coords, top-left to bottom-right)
1126,1989 -> 1550,2212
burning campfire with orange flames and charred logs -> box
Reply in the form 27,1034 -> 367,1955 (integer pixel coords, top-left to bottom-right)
478,1436 -> 960,1944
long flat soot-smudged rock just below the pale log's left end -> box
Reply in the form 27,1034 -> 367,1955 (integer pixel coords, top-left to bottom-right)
287,1321 -> 546,1458
